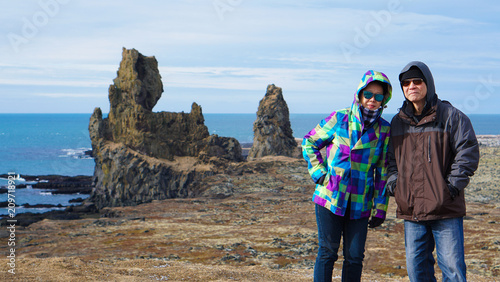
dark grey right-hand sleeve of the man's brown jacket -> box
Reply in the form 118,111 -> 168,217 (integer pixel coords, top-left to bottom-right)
447,110 -> 479,190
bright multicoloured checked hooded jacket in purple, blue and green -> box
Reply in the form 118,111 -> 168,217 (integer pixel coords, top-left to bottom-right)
302,71 -> 392,219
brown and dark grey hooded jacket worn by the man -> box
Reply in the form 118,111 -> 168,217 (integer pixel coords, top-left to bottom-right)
389,62 -> 479,221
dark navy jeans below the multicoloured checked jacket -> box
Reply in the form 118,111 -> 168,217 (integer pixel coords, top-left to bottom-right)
314,204 -> 368,281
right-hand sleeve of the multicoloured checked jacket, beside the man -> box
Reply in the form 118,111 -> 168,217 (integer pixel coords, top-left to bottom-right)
372,127 -> 390,219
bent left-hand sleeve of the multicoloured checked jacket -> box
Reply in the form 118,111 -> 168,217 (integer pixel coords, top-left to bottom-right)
302,112 -> 337,183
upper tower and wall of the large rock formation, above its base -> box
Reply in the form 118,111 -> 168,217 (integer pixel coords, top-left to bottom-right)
102,49 -> 217,160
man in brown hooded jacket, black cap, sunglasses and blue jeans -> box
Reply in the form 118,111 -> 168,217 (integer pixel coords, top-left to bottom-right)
387,61 -> 479,281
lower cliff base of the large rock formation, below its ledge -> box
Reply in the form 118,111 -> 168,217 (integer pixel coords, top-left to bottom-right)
90,141 -> 215,209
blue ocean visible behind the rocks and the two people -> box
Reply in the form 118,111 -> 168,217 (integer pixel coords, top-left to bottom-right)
0,113 -> 500,214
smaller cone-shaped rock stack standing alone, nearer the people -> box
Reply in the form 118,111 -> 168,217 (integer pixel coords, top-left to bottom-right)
248,84 -> 299,160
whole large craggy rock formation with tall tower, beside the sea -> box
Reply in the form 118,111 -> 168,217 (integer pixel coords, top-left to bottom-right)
89,48 -> 243,209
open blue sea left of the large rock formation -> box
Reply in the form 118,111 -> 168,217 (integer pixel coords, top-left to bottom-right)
0,114 -> 94,176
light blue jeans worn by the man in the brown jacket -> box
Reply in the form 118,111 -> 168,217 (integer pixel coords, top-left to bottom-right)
405,217 -> 467,282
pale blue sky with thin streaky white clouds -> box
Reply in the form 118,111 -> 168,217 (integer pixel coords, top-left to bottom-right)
0,0 -> 500,114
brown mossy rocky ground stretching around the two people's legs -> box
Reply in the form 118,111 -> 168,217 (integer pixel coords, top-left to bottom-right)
0,146 -> 500,281
